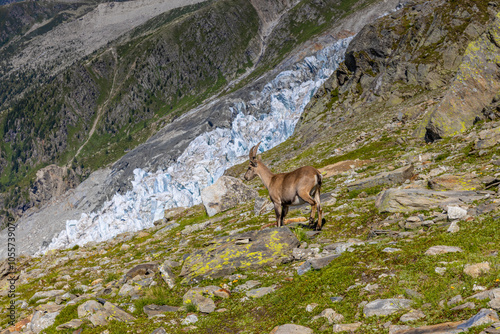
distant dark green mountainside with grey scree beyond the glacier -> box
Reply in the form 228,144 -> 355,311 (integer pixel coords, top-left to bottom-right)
0,0 -> 388,227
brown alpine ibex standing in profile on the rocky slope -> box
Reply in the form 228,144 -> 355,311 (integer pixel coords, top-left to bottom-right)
245,143 -> 323,230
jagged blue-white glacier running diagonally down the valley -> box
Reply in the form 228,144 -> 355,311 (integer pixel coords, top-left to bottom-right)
43,37 -> 353,250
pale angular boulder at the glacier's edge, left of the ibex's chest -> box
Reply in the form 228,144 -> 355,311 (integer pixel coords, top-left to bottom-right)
201,176 -> 259,217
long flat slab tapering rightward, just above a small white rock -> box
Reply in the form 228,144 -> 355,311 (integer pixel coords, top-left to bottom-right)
375,189 -> 486,212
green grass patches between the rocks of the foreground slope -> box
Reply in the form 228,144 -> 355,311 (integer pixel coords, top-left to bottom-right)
2,114 -> 500,333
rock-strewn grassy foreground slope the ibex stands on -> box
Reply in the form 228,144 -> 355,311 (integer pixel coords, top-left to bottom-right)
1,62 -> 500,334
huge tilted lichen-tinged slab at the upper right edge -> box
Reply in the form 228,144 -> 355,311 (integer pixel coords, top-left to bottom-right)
424,14 -> 500,141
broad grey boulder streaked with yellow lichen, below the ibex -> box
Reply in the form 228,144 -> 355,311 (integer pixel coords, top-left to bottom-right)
180,227 -> 300,283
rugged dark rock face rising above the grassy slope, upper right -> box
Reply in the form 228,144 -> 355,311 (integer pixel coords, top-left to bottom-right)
296,0 -> 500,142
